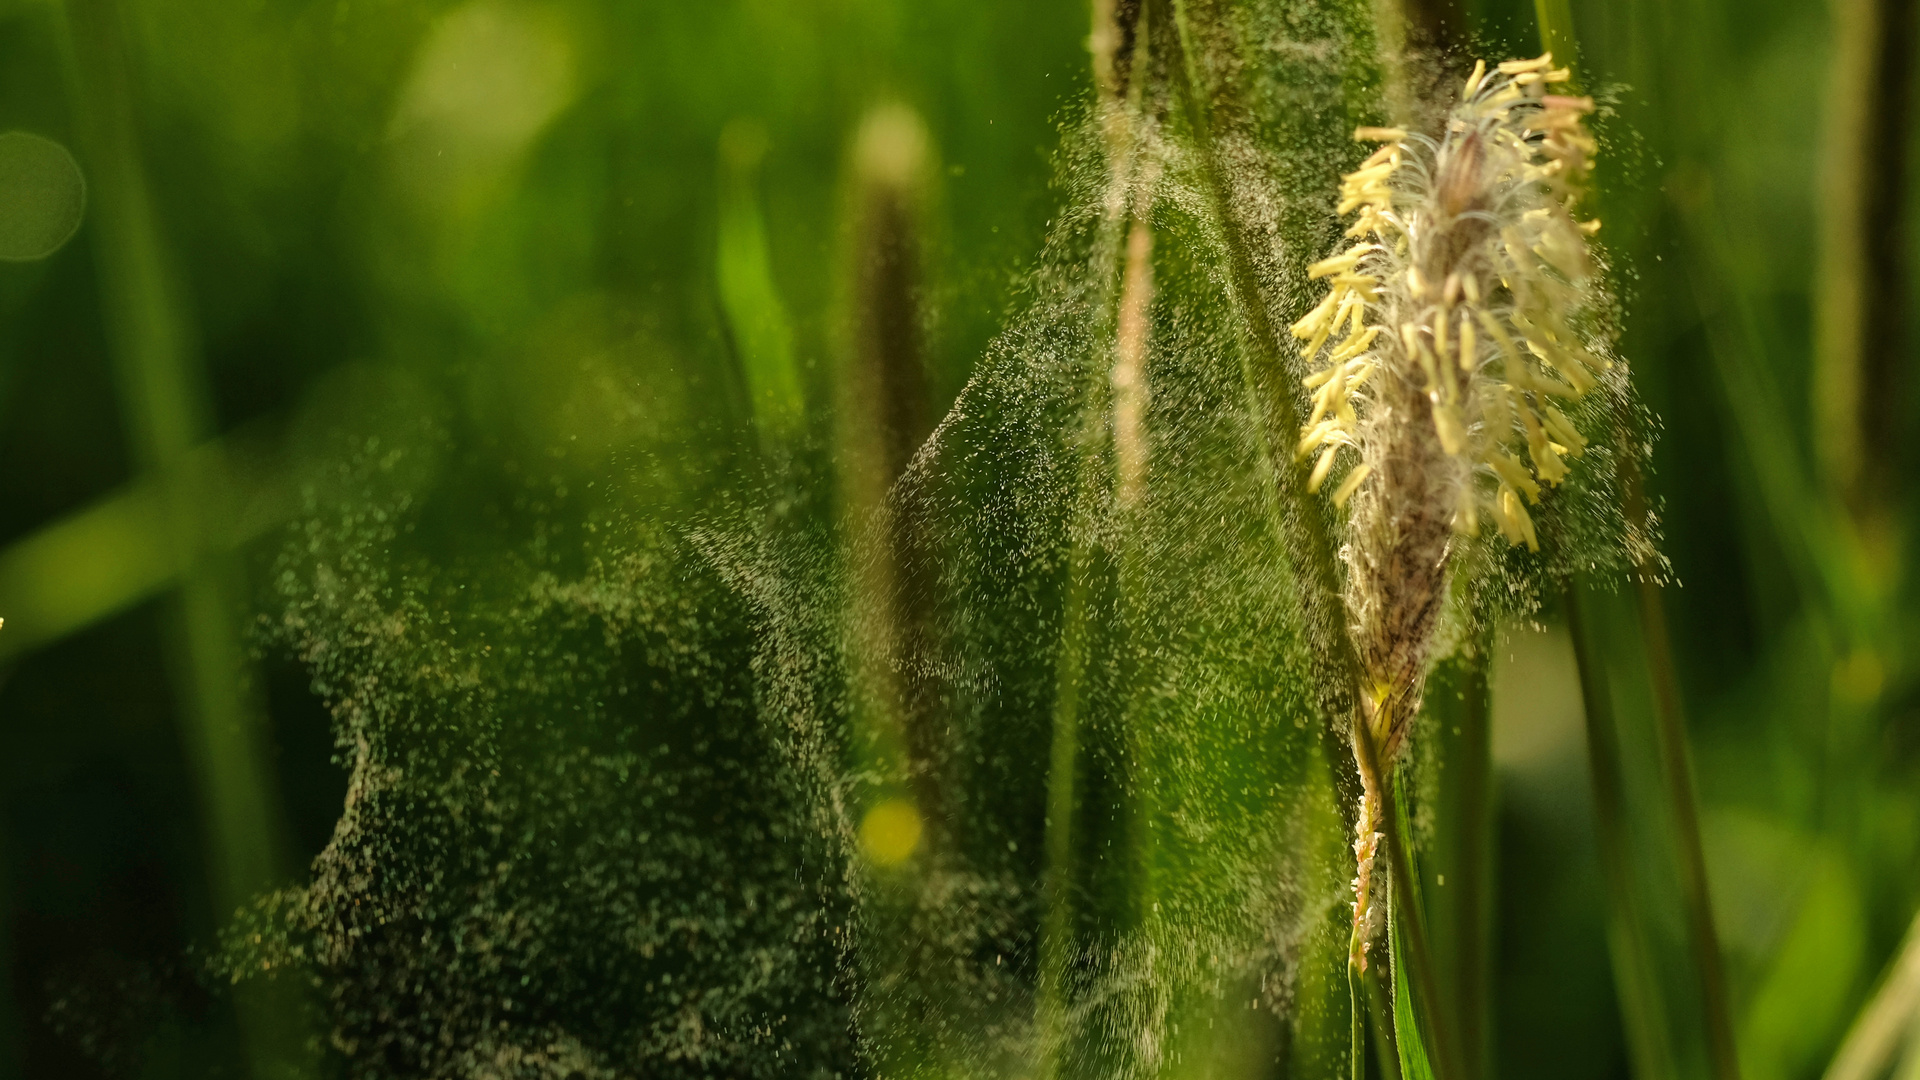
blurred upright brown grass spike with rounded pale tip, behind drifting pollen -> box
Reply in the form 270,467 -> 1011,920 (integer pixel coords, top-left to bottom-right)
835,104 -> 954,1076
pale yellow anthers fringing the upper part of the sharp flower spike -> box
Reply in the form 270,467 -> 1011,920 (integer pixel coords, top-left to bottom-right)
1290,54 -> 1611,550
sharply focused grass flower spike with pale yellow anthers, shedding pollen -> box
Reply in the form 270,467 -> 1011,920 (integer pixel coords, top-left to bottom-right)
1292,54 -> 1609,960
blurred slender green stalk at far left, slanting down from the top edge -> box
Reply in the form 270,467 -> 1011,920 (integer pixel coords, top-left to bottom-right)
56,0 -> 305,1076
